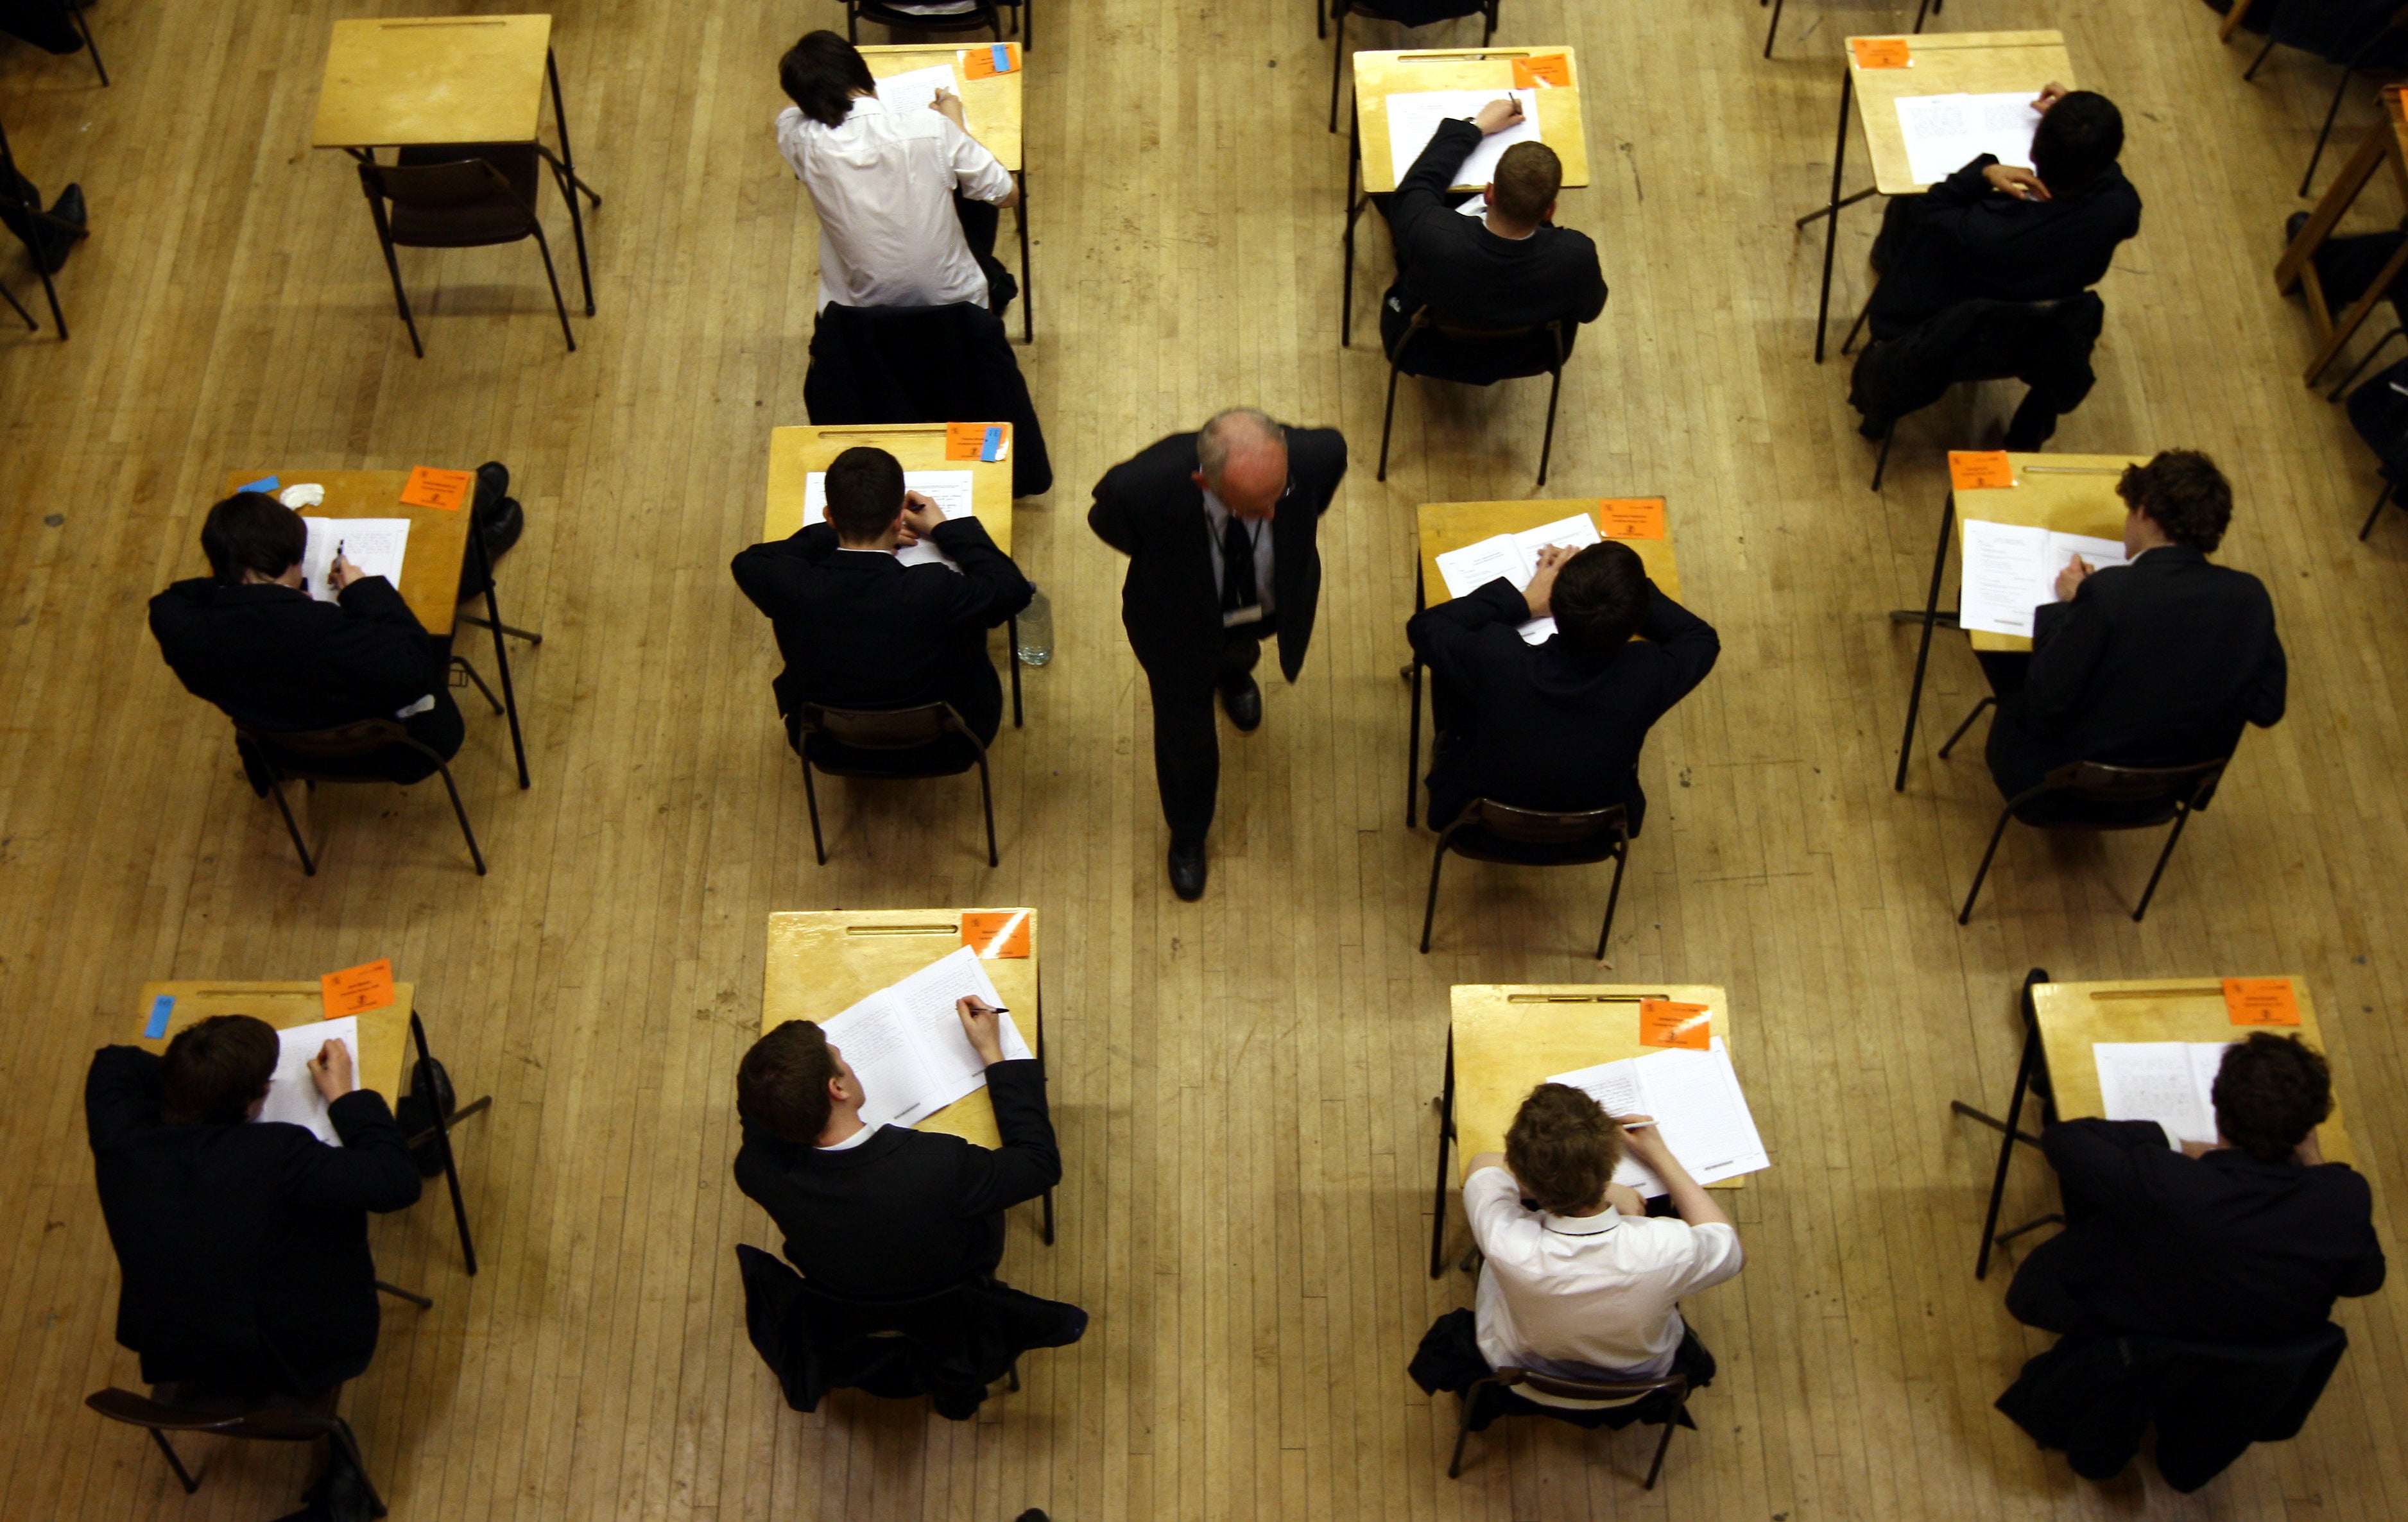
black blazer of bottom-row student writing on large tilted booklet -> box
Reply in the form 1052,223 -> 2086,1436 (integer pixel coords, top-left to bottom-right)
737,1059 -> 1062,1298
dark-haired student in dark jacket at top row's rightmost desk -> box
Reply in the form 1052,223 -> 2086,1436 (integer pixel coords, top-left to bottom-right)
1866,84 -> 2141,339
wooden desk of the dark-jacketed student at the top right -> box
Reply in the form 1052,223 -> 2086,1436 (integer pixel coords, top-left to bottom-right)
1796,31 -> 2078,364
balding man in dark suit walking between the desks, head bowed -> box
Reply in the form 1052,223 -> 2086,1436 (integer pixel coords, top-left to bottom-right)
1086,407 -> 1346,901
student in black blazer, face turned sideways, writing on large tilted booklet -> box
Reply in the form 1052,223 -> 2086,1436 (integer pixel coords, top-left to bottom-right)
737,1000 -> 1062,1301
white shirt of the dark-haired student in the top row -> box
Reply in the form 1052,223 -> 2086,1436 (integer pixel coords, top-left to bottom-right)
778,96 -> 1011,306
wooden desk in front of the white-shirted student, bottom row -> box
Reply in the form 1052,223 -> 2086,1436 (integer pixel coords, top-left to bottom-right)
1431,982 -> 1748,1279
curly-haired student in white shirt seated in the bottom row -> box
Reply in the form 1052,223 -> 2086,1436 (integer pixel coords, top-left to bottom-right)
1411,1084 -> 1743,1430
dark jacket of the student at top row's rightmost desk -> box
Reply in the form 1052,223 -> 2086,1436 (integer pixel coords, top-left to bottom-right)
1869,154 -> 2141,337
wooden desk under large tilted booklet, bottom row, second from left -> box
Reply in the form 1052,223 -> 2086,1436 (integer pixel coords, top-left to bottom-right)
761,908 -> 1053,1146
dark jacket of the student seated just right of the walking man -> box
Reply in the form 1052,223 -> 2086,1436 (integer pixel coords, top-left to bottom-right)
1404,576 -> 1722,834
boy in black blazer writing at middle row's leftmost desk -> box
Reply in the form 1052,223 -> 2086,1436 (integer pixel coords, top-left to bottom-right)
150,492 -> 465,792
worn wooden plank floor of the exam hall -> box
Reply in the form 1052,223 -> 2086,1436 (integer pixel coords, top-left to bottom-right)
0,0 -> 2408,1522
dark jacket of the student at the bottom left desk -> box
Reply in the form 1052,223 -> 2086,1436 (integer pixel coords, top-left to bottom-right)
84,1045 -> 419,1394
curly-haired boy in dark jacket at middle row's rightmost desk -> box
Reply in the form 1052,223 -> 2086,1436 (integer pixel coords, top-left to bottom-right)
1982,450 -> 2285,797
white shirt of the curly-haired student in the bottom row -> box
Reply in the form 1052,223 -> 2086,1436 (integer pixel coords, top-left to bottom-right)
1464,1166 -> 1741,1407
